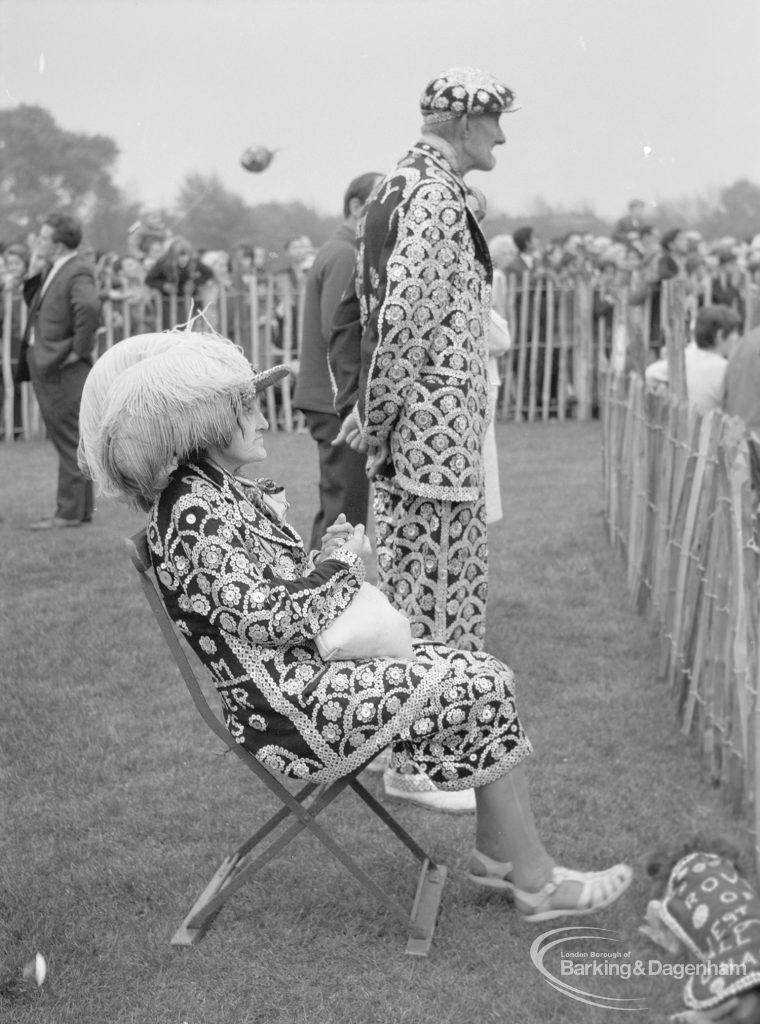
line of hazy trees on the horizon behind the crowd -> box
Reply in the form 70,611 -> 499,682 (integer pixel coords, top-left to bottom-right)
0,103 -> 760,253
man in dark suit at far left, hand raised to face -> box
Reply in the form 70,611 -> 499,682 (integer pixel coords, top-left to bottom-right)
16,213 -> 100,529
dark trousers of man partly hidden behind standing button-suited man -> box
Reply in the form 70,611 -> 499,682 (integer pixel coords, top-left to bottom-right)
304,412 -> 370,549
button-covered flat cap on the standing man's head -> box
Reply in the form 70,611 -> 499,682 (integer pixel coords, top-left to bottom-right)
420,68 -> 519,125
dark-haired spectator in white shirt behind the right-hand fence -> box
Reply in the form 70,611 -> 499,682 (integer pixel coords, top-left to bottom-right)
646,305 -> 742,416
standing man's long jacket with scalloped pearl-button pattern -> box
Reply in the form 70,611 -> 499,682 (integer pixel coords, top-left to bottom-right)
356,141 -> 492,501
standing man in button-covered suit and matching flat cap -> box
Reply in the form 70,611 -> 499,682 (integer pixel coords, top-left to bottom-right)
353,68 -> 514,650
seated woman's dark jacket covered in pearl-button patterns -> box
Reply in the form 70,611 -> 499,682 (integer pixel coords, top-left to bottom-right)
147,461 -> 366,768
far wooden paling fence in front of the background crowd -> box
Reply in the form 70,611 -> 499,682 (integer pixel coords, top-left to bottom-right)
3,273 -> 760,439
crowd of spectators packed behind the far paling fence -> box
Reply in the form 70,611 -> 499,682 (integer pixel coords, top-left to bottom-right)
0,200 -> 760,430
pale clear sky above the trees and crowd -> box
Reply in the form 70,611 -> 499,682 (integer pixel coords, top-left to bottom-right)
0,0 -> 760,217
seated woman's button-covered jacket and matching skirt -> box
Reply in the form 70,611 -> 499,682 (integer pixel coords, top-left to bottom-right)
147,459 -> 532,790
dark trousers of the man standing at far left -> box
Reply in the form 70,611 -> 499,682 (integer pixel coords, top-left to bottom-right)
29,356 -> 92,520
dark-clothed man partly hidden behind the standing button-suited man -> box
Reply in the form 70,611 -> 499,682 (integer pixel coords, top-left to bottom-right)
293,173 -> 381,550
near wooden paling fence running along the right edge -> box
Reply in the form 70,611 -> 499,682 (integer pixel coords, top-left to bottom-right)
602,373 -> 760,865
